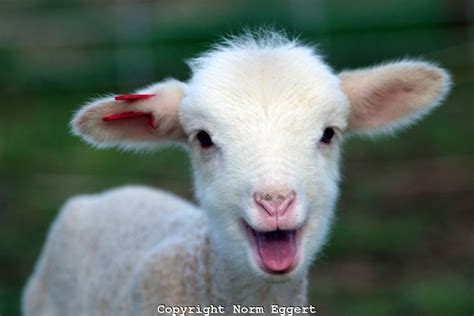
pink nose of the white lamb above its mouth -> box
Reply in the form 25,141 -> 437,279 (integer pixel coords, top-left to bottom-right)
253,191 -> 296,216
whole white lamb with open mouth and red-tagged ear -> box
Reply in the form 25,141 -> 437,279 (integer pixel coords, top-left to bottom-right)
23,32 -> 450,315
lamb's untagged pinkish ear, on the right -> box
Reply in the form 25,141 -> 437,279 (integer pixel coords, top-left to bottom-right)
339,61 -> 451,133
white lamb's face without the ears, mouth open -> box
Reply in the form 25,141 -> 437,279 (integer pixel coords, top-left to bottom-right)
180,48 -> 348,279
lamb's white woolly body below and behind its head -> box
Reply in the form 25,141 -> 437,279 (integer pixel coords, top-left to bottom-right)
24,186 -> 305,315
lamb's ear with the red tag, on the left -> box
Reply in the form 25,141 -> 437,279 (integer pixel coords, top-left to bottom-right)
71,80 -> 186,149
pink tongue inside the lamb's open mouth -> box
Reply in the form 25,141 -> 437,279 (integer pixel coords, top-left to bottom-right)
256,231 -> 296,272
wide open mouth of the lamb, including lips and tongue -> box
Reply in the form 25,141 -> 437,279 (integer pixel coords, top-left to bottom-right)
244,223 -> 301,274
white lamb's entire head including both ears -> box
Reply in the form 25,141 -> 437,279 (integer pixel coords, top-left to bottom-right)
72,34 -> 450,280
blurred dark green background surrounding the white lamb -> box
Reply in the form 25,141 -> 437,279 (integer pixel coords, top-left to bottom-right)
0,0 -> 474,316
